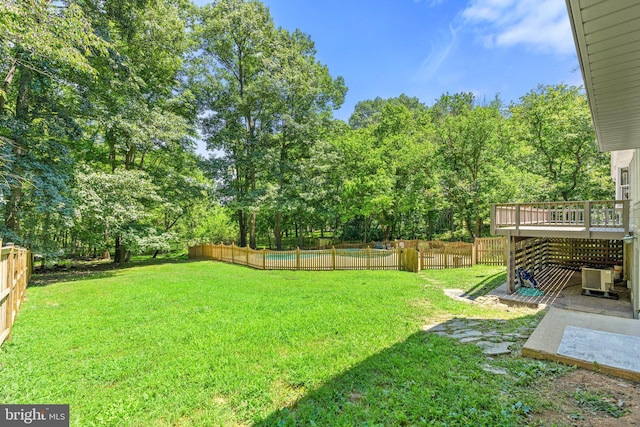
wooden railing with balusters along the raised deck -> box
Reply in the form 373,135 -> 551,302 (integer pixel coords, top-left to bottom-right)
491,200 -> 629,234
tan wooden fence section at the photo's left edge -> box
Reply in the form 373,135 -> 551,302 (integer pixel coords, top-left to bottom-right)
0,244 -> 32,345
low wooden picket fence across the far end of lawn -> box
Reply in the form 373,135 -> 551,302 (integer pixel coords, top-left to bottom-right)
189,238 -> 506,272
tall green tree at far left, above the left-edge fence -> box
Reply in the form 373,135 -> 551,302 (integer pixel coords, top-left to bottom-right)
0,0 -> 108,243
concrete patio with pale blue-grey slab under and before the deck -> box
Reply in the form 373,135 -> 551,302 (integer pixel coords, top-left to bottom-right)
489,267 -> 640,381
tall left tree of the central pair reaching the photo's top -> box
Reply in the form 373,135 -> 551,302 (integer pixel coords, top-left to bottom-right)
193,0 -> 276,247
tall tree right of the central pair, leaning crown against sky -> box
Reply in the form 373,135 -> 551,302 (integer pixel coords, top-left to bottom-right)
267,29 -> 346,250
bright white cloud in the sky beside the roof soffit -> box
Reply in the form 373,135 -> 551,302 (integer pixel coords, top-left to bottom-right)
462,0 -> 575,55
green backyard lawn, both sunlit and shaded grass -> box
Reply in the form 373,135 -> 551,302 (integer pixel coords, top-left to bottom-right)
0,261 -> 555,426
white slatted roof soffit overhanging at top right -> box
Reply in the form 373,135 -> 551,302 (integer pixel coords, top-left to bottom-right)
566,0 -> 640,151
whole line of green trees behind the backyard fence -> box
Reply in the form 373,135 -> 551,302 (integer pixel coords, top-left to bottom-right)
0,0 -> 612,262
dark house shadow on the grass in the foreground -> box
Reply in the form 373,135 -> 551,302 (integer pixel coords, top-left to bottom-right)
254,316 -> 537,427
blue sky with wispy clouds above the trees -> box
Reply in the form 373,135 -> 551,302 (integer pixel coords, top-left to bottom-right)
195,0 -> 582,120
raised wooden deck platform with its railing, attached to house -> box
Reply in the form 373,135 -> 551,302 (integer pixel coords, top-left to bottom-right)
491,200 -> 629,239
